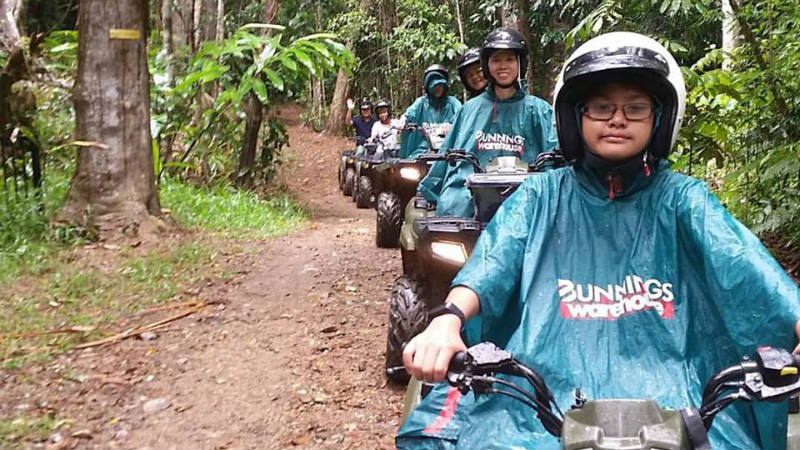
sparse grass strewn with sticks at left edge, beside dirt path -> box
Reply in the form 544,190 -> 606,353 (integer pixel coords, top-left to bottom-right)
0,243 -> 232,369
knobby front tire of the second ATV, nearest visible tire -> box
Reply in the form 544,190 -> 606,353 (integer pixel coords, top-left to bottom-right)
386,275 -> 428,384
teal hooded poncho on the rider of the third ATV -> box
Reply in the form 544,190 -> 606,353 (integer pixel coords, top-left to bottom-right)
400,72 -> 461,159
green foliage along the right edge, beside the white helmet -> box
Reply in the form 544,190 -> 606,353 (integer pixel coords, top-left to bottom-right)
680,2 -> 800,246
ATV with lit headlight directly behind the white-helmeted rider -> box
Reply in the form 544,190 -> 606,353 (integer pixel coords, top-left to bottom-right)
386,150 -> 564,383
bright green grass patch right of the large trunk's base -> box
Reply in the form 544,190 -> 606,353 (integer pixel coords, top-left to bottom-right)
161,178 -> 308,238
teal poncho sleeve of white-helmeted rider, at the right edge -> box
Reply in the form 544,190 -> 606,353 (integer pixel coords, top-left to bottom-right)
679,180 -> 800,354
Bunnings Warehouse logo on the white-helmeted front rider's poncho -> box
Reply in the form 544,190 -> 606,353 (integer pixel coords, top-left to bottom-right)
558,275 -> 675,320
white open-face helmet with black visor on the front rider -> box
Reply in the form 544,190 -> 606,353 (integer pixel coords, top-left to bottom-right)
553,32 -> 686,161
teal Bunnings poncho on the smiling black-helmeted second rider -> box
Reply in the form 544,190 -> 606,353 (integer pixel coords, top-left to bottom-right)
417,85 -> 558,217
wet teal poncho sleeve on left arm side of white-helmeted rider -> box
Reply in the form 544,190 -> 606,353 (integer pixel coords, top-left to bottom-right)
452,177 -> 538,330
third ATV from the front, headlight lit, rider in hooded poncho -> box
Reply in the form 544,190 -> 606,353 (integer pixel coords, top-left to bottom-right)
372,123 -> 454,248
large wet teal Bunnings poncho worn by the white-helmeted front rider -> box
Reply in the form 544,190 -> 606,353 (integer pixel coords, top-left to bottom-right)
397,162 -> 800,449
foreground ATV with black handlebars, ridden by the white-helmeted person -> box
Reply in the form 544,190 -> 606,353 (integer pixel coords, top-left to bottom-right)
394,342 -> 800,450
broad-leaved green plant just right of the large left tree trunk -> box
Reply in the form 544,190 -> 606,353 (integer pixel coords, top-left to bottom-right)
152,23 -> 353,185
